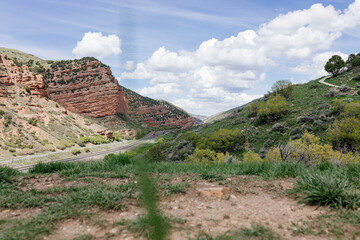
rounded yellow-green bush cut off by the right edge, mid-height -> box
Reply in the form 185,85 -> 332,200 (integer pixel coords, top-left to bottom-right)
327,117 -> 360,151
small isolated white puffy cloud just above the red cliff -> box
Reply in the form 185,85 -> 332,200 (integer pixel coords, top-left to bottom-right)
72,32 -> 121,59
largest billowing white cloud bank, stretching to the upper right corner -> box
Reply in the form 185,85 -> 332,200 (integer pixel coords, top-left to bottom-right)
121,0 -> 360,115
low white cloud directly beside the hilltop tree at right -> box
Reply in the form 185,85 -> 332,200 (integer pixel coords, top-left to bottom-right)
291,51 -> 348,78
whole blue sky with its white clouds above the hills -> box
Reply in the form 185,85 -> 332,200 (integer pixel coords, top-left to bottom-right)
0,0 -> 360,115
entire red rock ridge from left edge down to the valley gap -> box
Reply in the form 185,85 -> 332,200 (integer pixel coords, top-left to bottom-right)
0,50 -> 194,128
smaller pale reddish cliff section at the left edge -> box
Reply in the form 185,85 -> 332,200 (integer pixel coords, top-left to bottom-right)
0,54 -> 47,97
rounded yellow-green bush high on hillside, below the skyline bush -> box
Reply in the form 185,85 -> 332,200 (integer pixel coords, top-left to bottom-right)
258,95 -> 289,122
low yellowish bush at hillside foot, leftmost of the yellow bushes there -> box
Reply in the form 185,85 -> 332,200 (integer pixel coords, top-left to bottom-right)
186,148 -> 229,164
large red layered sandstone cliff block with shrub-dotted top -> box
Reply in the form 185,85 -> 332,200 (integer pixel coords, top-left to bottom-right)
45,58 -> 127,117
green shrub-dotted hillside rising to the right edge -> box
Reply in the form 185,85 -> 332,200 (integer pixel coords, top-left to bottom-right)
162,67 -> 360,163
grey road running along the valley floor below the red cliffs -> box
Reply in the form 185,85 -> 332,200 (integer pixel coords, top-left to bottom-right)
15,131 -> 167,172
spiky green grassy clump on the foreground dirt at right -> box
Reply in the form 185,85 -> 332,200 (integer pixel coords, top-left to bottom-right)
292,171 -> 360,209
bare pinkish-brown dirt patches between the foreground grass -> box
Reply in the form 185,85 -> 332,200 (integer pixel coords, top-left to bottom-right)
0,174 -> 334,240
